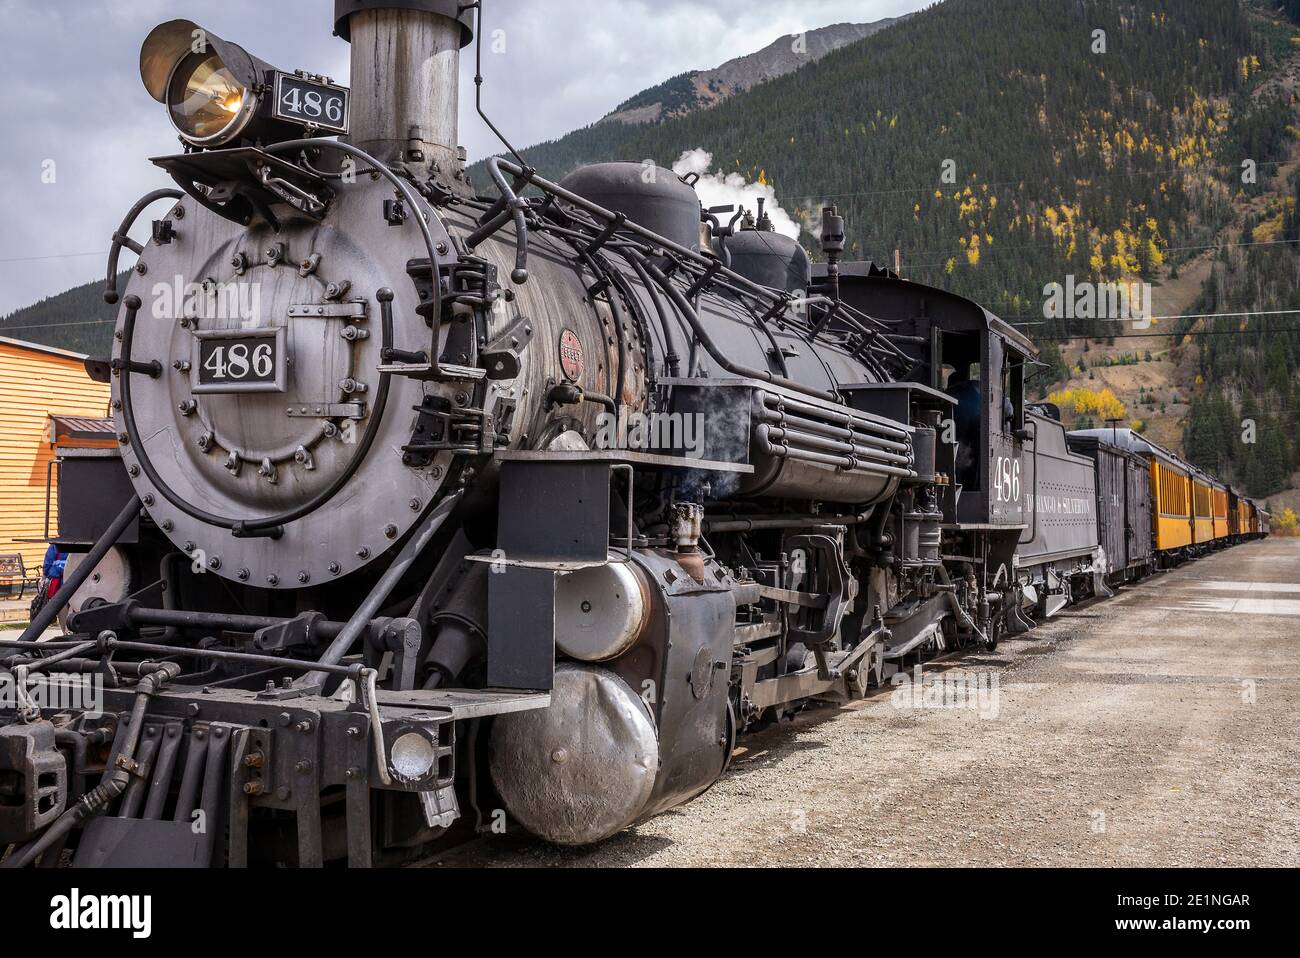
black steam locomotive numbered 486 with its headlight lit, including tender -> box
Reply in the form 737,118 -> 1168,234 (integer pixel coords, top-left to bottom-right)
0,0 -> 1260,867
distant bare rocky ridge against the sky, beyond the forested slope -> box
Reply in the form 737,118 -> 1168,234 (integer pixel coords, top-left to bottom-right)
601,17 -> 904,125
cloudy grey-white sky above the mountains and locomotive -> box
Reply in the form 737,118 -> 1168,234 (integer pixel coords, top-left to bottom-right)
0,0 -> 927,321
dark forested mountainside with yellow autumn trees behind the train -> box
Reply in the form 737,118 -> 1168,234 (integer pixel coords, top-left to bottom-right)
0,0 -> 1300,497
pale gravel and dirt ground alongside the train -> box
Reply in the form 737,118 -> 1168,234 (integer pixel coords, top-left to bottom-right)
436,538 -> 1300,867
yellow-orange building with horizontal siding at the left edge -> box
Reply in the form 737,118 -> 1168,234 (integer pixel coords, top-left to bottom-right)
0,337 -> 112,574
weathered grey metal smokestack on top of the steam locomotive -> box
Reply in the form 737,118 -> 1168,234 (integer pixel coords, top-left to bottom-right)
334,0 -> 473,174
